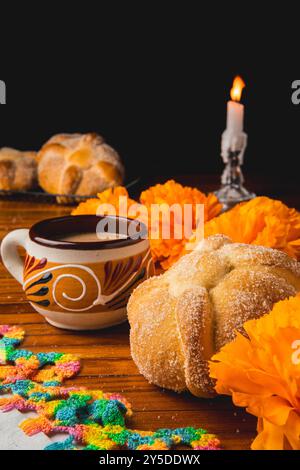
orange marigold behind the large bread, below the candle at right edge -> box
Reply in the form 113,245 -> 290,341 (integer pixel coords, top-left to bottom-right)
204,197 -> 300,260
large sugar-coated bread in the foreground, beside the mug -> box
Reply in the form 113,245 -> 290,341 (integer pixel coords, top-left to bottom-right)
128,235 -> 300,397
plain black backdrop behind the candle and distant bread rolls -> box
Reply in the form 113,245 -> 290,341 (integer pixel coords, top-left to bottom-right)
0,6 -> 300,181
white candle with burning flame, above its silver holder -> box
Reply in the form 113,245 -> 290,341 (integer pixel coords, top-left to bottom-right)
222,77 -> 245,158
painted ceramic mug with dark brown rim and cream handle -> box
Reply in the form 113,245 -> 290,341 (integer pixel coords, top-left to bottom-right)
1,215 -> 154,330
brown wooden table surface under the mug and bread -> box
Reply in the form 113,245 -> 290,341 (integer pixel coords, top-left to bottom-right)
0,176 -> 300,449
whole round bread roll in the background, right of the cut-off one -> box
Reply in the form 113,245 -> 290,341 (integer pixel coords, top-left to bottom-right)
38,133 -> 124,196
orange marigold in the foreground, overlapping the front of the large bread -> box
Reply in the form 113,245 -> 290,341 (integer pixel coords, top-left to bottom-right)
210,294 -> 300,450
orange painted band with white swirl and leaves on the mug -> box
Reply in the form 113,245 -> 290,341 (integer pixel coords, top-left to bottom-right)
23,249 -> 154,313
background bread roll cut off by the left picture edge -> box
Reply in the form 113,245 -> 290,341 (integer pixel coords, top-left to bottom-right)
0,147 -> 37,191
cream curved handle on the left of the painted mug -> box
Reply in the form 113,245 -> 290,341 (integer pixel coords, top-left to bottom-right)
1,228 -> 29,284
